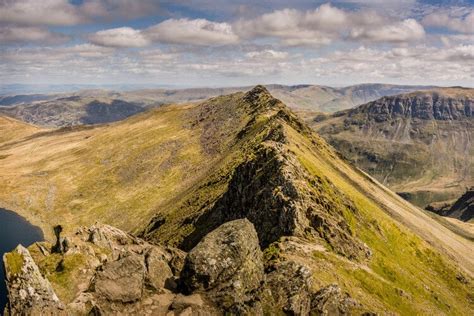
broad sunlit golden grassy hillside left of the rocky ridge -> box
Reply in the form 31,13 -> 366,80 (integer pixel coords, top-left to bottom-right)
0,94 -> 256,235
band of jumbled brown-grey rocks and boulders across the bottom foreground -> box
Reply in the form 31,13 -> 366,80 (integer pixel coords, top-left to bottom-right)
4,219 -> 362,315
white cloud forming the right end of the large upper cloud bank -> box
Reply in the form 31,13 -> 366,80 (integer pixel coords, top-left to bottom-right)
350,19 -> 425,43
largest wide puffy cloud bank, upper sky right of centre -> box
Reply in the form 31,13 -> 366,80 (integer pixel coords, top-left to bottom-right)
234,4 -> 425,45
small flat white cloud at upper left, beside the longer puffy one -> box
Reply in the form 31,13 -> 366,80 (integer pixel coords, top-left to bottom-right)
89,27 -> 150,47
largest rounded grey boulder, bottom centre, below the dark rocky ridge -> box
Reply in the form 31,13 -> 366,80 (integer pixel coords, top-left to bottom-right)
181,219 -> 264,311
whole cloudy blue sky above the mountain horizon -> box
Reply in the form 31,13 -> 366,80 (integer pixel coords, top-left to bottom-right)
0,0 -> 474,87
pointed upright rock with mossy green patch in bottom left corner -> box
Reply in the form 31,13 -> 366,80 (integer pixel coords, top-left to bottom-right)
3,245 -> 66,315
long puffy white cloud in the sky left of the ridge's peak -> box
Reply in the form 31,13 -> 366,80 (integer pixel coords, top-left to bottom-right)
144,19 -> 239,45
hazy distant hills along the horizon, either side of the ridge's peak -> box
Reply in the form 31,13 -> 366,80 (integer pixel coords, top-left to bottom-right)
0,84 -> 434,127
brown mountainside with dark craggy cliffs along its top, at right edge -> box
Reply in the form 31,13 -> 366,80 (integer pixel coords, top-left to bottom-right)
312,88 -> 474,207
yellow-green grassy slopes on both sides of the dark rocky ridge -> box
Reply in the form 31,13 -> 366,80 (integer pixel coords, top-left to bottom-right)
0,89 -> 474,315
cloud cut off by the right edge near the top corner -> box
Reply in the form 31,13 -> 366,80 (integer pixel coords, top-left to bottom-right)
422,10 -> 474,34
